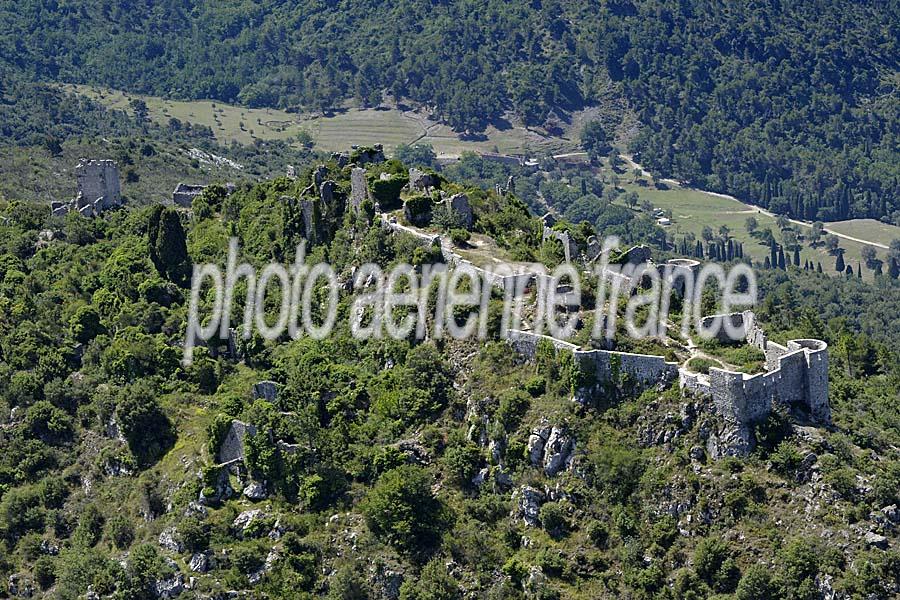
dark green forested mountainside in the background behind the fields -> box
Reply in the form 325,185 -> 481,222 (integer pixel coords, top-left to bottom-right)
0,0 -> 900,221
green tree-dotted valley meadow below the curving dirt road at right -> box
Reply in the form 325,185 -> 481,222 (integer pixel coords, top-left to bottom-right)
617,184 -> 898,280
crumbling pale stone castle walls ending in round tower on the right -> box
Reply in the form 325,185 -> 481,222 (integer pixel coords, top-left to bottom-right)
370,158 -> 831,458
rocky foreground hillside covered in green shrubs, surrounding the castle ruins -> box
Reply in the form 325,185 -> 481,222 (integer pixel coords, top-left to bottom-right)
0,156 -> 900,600
